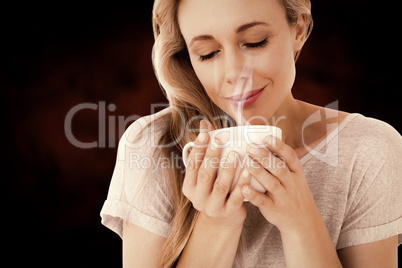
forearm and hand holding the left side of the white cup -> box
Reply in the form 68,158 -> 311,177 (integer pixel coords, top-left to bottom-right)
177,121 -> 251,268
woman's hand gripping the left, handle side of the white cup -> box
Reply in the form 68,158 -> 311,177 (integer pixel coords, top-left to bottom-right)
182,120 -> 251,231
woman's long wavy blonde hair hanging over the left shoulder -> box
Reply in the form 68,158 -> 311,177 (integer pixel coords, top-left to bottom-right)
152,0 -> 313,267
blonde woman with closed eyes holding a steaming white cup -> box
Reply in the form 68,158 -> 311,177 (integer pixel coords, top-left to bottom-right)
101,0 -> 402,268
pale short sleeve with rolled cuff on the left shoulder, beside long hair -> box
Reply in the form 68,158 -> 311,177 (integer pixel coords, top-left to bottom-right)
100,112 -> 172,237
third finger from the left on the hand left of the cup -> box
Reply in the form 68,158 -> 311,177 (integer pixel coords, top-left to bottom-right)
211,151 -> 239,206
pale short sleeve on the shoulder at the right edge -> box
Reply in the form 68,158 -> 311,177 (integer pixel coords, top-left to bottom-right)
337,123 -> 402,249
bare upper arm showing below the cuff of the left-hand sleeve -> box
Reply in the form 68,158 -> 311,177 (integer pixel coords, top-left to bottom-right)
123,222 -> 166,268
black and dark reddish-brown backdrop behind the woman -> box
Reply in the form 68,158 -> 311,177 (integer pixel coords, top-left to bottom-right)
0,0 -> 402,267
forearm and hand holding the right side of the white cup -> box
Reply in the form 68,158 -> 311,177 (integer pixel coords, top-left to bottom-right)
243,136 -> 341,268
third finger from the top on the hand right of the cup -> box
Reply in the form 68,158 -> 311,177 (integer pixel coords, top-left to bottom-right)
245,154 -> 284,195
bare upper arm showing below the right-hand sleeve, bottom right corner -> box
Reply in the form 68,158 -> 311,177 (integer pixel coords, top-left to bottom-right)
338,236 -> 398,268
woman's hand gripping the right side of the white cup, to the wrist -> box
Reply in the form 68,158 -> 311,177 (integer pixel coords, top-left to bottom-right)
243,136 -> 322,233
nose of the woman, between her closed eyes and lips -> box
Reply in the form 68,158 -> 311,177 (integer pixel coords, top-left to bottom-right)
224,50 -> 251,85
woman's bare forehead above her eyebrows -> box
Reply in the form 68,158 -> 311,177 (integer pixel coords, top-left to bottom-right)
178,0 -> 286,38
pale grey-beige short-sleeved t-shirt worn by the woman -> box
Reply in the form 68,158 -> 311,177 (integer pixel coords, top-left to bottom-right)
101,108 -> 402,267
